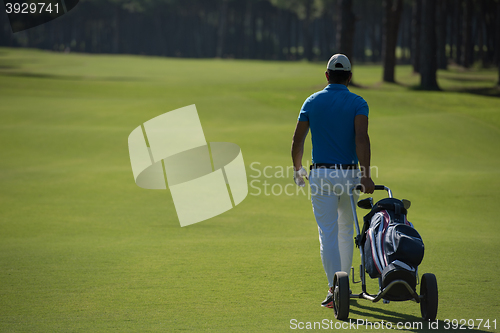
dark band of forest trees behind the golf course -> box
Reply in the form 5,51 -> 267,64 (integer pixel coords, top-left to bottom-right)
0,0 -> 500,85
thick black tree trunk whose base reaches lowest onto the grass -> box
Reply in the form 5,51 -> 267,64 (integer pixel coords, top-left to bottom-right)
420,0 -> 439,90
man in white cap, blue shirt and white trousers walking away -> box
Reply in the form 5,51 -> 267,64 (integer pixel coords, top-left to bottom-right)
292,54 -> 375,308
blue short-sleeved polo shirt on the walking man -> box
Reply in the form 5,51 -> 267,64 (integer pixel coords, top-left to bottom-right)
299,84 -> 368,164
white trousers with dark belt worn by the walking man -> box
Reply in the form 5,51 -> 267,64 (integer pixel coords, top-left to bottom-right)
309,169 -> 359,287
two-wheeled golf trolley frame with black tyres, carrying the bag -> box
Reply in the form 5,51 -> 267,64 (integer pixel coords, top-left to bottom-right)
333,185 -> 438,321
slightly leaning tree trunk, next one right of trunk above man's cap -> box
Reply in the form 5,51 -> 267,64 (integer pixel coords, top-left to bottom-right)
382,0 -> 403,82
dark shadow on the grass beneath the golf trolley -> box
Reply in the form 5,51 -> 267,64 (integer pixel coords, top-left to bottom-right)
349,299 -> 491,332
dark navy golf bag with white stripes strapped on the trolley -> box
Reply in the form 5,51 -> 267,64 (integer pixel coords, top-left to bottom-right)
361,198 -> 424,301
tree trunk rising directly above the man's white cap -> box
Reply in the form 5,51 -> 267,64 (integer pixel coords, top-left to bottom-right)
335,0 -> 355,61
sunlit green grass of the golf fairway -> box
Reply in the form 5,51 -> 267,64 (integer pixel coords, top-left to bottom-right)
0,49 -> 500,332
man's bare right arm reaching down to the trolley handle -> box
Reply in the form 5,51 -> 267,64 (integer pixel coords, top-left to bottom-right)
354,115 -> 375,193
